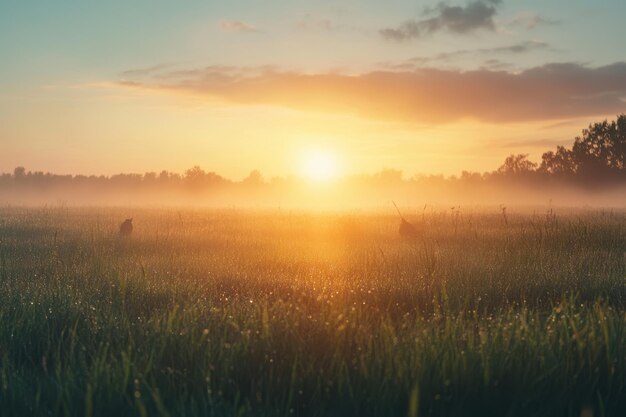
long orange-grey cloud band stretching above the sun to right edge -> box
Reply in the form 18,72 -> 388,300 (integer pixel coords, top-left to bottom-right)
120,62 -> 626,123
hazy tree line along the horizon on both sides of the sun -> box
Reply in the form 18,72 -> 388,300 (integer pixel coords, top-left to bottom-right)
0,114 -> 626,191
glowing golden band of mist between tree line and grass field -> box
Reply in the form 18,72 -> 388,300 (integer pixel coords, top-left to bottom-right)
0,170 -> 626,211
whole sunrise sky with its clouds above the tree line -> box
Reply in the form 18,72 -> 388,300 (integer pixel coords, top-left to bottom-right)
0,0 -> 626,179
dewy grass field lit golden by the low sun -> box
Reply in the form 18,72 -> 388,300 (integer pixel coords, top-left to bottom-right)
0,208 -> 626,417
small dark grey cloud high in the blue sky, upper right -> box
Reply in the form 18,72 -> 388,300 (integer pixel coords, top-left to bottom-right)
380,0 -> 501,42
